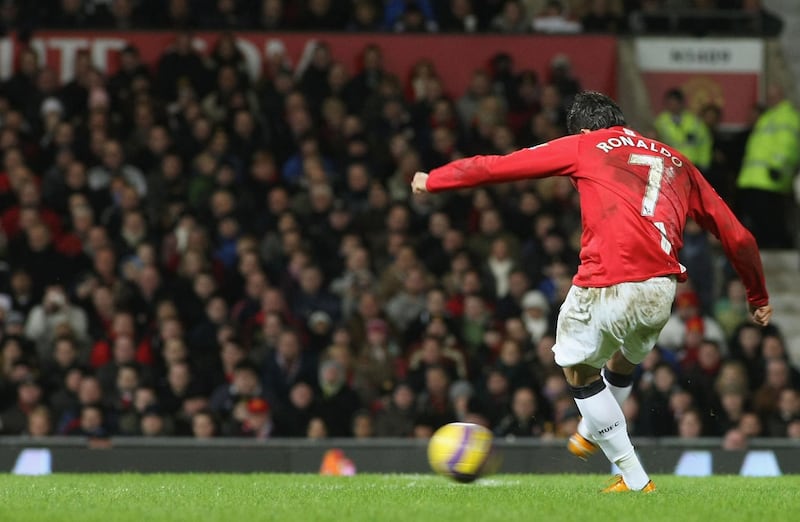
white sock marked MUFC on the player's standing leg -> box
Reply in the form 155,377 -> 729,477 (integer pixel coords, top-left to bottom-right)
575,387 -> 650,490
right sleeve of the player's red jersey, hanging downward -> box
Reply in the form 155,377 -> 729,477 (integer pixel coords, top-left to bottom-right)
689,169 -> 769,306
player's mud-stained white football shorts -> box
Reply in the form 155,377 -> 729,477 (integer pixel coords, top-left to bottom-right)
553,277 -> 677,368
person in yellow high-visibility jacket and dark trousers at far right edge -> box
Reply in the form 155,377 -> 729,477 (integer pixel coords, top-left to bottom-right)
736,85 -> 800,248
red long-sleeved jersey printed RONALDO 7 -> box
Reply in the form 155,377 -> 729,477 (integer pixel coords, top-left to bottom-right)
427,127 -> 769,306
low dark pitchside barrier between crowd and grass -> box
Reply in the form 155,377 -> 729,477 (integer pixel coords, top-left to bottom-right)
0,437 -> 800,476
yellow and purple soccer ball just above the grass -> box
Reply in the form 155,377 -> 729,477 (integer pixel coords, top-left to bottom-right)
428,422 -> 492,483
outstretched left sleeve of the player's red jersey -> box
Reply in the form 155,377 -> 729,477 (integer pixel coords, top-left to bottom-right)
426,135 -> 580,192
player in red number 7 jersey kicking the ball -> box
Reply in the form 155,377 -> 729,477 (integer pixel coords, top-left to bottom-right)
411,92 -> 772,492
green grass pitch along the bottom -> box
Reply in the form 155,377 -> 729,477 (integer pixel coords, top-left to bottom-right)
0,474 -> 800,522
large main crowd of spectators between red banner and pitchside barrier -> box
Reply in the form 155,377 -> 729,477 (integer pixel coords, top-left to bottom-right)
0,20 -> 800,445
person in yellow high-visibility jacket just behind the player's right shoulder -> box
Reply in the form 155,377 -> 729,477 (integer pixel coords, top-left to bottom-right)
653,88 -> 713,172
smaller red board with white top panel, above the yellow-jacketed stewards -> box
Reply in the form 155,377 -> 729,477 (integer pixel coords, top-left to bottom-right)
636,38 -> 764,127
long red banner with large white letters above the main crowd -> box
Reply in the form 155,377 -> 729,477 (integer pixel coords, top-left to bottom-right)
0,31 -> 617,96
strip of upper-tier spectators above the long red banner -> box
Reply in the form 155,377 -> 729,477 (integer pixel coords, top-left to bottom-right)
0,0 -> 783,35
